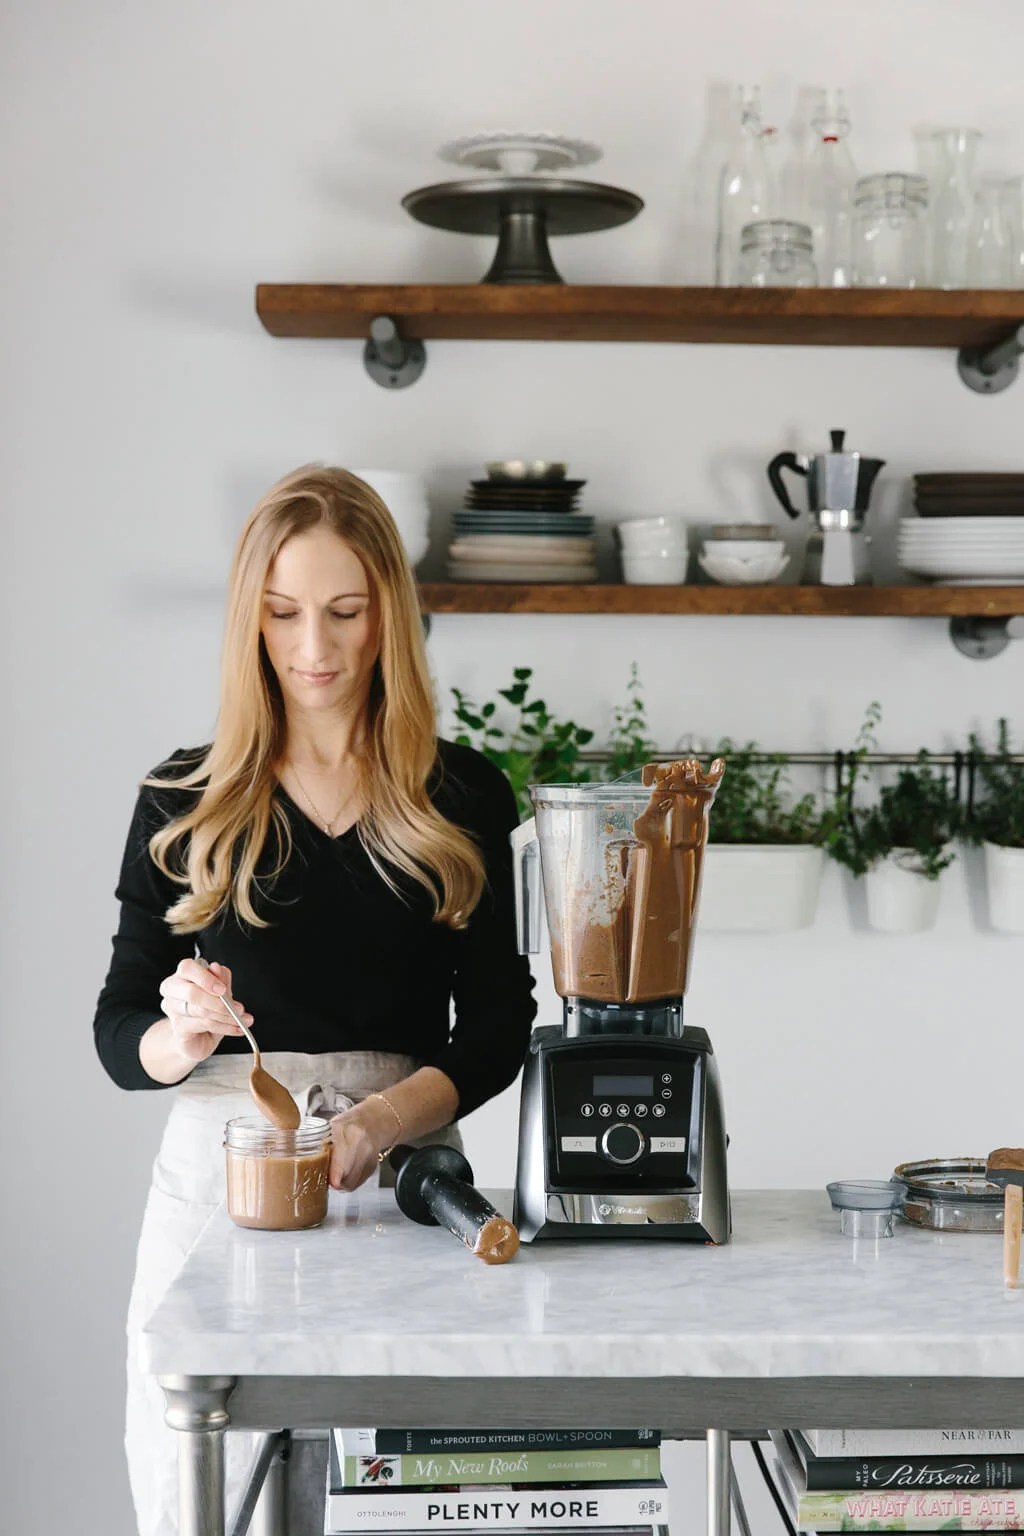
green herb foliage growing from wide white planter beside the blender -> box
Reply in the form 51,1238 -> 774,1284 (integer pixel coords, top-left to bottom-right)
708,736 -> 823,843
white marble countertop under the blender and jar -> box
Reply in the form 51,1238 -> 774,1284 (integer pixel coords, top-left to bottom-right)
144,1190 -> 1024,1379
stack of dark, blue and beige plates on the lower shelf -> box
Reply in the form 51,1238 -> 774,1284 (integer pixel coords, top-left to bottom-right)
448,461 -> 597,582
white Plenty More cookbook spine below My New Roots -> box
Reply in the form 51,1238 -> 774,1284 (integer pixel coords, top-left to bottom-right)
324,1479 -> 668,1536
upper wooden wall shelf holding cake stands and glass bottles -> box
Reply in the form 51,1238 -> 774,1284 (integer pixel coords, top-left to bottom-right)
256,283 -> 1024,349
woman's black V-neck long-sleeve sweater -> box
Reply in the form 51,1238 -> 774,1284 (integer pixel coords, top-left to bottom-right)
94,742 -> 536,1117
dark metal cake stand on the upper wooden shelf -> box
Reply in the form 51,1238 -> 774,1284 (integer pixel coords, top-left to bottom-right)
402,177 -> 643,283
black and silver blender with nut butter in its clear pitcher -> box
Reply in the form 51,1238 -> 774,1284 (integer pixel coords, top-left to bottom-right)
511,759 -> 731,1243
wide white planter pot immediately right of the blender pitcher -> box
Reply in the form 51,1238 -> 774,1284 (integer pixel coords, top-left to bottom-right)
697,843 -> 824,934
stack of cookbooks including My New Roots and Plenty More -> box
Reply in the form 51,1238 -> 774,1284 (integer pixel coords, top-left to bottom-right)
324,1428 -> 668,1536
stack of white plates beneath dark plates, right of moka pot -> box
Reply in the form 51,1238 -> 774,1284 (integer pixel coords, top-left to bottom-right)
897,516 -> 1024,587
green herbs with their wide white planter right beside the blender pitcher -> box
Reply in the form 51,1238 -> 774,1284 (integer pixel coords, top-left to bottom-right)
699,737 -> 824,932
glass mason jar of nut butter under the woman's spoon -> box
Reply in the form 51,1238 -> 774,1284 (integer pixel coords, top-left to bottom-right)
224,1115 -> 330,1232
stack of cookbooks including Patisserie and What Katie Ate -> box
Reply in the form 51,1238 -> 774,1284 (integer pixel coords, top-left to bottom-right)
771,1428 -> 1024,1531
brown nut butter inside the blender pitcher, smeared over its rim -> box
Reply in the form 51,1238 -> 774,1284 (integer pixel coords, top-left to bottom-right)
553,757 -> 725,1003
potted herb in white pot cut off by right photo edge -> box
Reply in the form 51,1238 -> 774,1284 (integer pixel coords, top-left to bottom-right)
967,719 -> 1024,934
